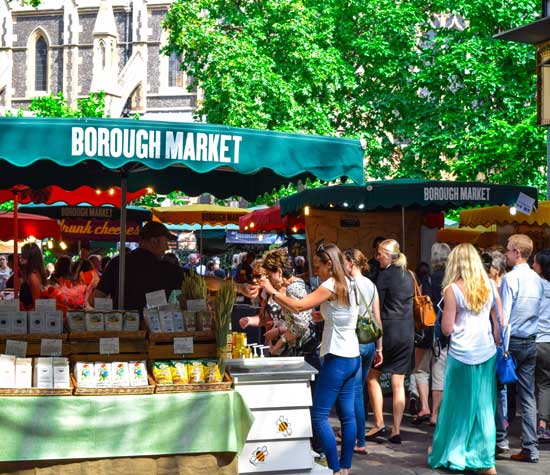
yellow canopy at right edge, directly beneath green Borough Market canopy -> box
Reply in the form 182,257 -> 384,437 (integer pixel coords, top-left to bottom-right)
460,201 -> 550,228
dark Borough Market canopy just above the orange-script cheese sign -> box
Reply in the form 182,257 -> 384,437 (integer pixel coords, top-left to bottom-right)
19,203 -> 153,222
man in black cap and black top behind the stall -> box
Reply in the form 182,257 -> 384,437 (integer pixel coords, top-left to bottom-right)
90,221 -> 183,310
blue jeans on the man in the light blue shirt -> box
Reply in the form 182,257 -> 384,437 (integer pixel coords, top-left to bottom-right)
497,337 -> 539,458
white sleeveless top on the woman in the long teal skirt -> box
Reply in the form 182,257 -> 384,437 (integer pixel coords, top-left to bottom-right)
449,284 -> 496,365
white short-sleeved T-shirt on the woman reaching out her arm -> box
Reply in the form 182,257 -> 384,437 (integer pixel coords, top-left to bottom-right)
321,277 -> 359,358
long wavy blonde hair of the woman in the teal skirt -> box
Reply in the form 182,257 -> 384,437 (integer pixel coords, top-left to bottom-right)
443,243 -> 491,313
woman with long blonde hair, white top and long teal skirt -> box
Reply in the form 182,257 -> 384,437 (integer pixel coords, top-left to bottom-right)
428,244 -> 502,475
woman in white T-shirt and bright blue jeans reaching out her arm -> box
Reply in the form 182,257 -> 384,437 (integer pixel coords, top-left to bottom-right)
261,244 -> 360,475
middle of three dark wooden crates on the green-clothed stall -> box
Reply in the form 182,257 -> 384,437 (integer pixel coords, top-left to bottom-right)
69,331 -> 147,355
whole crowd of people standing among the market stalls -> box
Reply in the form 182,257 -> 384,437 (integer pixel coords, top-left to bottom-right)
0,222 -> 550,475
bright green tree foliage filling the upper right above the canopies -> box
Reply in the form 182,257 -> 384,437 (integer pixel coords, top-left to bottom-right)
164,0 -> 545,194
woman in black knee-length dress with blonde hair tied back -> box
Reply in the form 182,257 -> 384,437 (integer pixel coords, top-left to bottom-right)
366,239 -> 414,444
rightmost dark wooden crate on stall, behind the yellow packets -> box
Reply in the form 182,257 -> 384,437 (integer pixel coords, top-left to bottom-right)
147,331 -> 216,361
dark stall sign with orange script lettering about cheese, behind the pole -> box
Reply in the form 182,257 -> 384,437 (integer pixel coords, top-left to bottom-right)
59,219 -> 140,242
